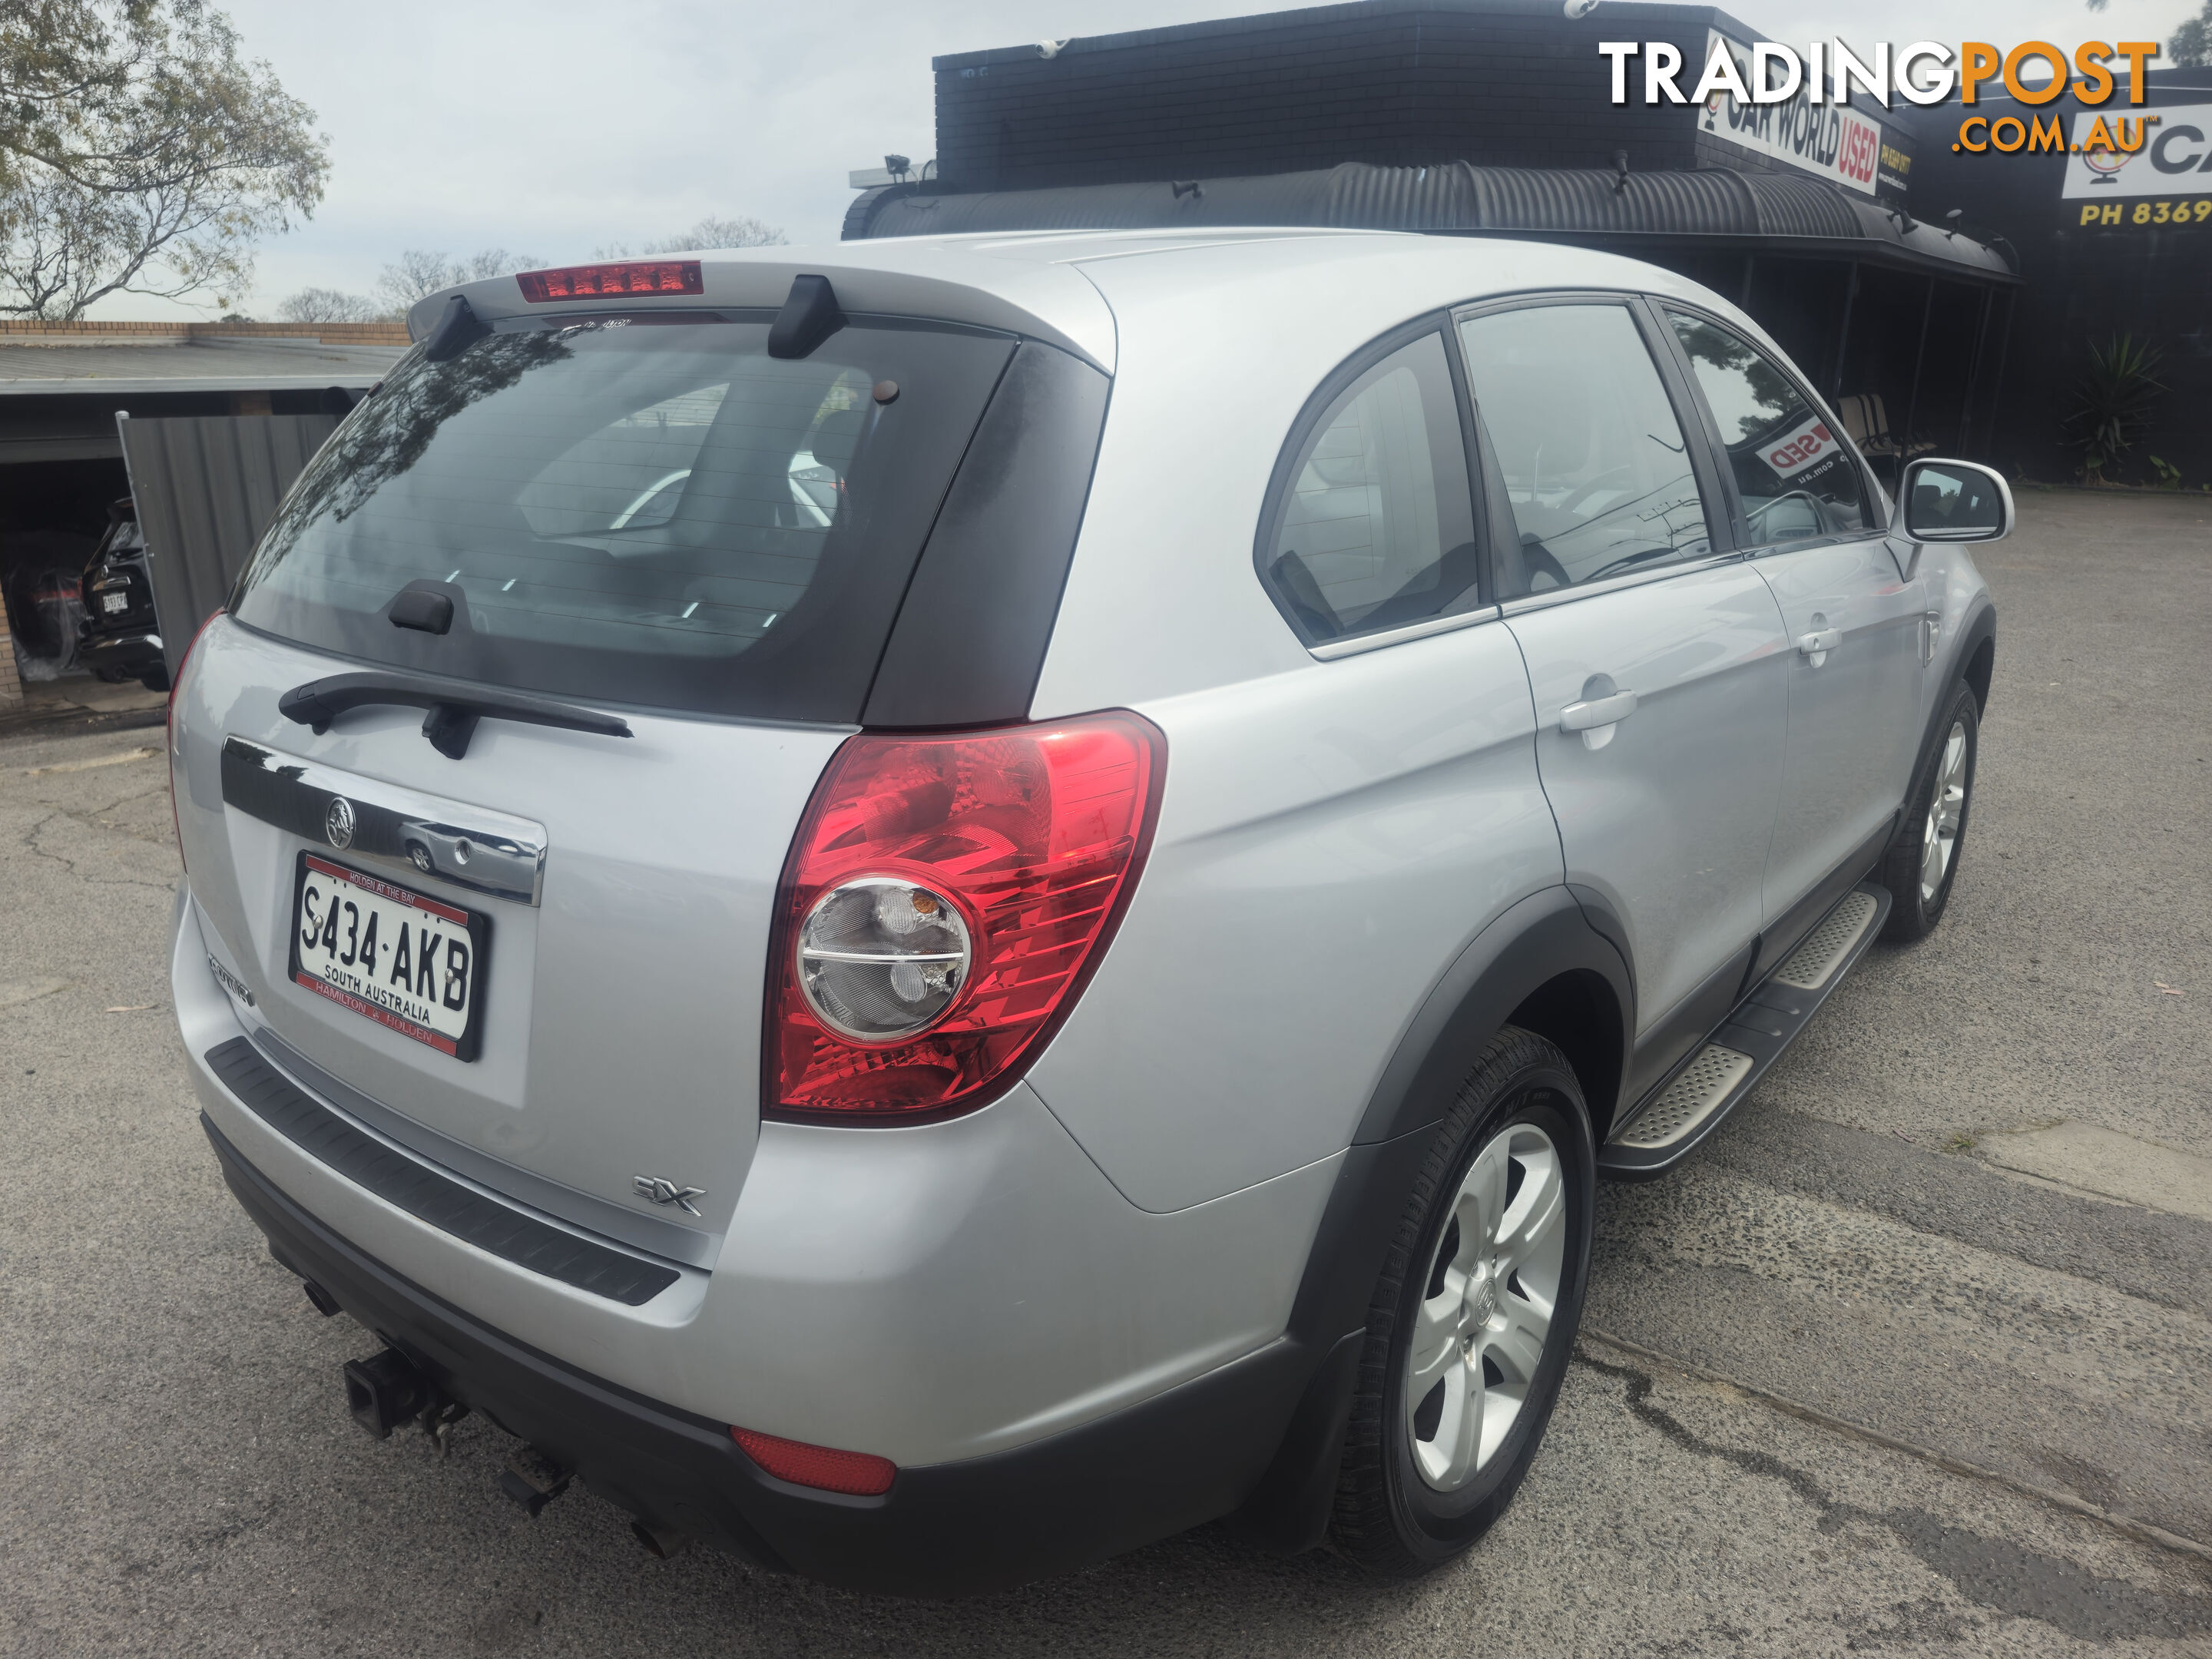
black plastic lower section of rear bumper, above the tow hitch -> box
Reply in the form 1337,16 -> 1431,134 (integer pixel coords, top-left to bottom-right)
199,1115 -> 1323,1597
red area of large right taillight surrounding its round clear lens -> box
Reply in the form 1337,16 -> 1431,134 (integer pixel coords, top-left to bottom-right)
763,712 -> 1168,1121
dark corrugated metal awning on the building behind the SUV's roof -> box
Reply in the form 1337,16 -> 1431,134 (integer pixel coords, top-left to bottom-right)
845,161 -> 2019,283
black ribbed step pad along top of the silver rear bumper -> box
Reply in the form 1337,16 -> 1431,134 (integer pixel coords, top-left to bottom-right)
208,1038 -> 684,1307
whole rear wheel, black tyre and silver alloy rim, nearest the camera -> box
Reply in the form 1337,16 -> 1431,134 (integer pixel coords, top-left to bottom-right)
1330,1026 -> 1597,1577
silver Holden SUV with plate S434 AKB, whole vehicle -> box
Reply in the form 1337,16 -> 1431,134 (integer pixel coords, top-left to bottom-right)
171,230 -> 2011,1594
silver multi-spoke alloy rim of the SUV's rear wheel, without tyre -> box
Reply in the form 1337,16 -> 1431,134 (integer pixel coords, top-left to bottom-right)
1405,1124 -> 1566,1491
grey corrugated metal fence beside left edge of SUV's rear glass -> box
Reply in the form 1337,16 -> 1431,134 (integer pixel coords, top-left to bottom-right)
115,414 -> 339,674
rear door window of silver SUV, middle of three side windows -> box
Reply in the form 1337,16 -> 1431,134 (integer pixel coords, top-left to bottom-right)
1460,305 -> 1712,598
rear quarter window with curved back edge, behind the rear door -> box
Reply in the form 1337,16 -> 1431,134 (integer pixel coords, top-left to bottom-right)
1261,334 -> 1480,644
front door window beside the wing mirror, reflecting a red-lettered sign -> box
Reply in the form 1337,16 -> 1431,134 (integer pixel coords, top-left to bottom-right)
1668,312 -> 1867,546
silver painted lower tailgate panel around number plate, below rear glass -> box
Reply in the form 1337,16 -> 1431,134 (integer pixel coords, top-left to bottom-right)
177,618 -> 843,1259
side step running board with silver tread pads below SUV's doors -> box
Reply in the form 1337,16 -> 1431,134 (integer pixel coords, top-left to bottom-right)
1597,880 -> 1889,1181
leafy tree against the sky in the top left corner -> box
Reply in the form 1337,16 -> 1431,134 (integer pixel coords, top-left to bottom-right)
0,0 -> 329,321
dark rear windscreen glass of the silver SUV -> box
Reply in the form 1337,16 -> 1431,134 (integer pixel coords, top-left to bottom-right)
234,312 -> 1015,721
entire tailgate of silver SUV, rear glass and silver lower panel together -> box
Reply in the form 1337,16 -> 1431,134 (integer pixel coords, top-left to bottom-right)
177,296 -> 1018,1265
